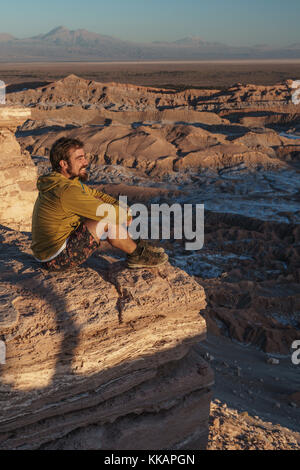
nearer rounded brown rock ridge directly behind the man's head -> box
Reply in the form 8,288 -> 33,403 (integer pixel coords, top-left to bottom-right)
18,115 -> 295,177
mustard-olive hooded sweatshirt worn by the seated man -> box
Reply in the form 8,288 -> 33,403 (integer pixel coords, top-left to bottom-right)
31,172 -> 126,261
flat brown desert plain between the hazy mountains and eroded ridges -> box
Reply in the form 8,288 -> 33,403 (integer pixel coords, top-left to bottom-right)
0,60 -> 300,90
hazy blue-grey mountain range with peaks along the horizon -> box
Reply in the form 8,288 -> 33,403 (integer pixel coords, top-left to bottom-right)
0,26 -> 300,62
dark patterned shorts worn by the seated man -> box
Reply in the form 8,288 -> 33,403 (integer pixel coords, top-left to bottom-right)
43,224 -> 99,271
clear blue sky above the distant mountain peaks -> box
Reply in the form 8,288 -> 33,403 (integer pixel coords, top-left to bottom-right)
0,0 -> 300,46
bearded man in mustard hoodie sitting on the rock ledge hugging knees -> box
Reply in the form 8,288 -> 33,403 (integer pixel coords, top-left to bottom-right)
31,137 -> 168,271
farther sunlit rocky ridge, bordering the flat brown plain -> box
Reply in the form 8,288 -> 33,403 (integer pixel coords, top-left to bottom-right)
8,75 -> 299,113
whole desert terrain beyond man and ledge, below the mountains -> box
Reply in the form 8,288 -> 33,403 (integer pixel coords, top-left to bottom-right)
0,61 -> 300,450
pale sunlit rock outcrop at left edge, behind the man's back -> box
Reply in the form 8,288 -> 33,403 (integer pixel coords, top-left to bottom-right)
0,105 -> 37,230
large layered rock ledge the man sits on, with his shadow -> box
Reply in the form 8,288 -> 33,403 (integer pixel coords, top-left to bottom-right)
0,227 -> 213,450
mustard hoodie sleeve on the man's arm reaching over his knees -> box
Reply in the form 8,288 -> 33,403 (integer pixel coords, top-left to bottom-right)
61,185 -> 127,224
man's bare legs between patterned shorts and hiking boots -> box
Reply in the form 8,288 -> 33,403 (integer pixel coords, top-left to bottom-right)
84,219 -> 137,254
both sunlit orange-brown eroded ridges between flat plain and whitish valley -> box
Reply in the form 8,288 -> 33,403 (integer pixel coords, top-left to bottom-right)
8,75 -> 299,179
